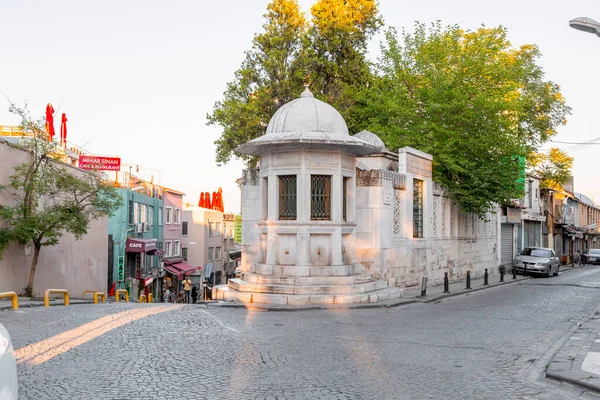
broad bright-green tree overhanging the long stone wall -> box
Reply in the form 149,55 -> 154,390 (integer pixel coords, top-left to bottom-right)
348,23 -> 570,215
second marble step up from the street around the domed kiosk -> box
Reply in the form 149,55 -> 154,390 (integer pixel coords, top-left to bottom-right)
228,279 -> 387,295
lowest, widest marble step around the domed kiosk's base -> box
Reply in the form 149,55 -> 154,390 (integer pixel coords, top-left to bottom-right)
217,286 -> 401,306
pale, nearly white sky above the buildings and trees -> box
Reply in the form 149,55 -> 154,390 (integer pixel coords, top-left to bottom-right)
0,0 -> 600,212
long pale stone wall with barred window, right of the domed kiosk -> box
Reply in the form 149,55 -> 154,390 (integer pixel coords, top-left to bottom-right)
356,148 -> 499,286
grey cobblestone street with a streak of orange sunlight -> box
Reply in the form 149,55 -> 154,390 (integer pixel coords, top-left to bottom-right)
0,267 -> 600,400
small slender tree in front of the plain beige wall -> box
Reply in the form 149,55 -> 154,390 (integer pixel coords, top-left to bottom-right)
0,106 -> 120,296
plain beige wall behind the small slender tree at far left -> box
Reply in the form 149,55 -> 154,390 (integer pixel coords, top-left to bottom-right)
0,139 -> 108,297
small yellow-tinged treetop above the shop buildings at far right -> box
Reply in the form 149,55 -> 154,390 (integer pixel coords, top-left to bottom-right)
528,147 -> 573,190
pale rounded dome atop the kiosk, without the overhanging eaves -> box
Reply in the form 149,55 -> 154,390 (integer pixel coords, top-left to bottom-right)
265,88 -> 349,135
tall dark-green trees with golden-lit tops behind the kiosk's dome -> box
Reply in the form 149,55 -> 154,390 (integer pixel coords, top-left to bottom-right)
207,0 -> 382,166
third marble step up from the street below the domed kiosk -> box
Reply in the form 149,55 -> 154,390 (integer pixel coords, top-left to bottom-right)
241,272 -> 373,286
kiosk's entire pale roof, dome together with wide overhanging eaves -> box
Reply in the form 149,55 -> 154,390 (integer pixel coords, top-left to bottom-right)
235,87 -> 381,156
